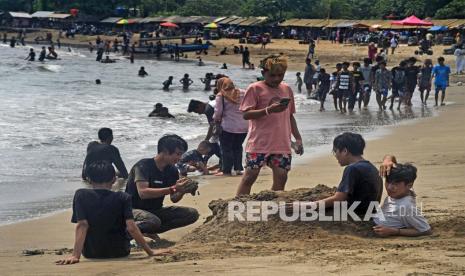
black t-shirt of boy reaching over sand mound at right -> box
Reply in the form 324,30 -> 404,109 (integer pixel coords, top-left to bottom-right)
337,160 -> 383,219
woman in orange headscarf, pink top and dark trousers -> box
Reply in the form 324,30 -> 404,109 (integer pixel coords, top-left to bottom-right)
213,77 -> 249,176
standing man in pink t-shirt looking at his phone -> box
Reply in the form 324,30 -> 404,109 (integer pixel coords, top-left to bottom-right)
237,55 -> 303,195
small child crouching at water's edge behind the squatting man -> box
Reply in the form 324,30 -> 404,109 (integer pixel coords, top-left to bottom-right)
176,141 -> 211,176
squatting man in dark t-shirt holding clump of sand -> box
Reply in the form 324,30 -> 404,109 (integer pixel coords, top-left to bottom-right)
126,135 -> 199,239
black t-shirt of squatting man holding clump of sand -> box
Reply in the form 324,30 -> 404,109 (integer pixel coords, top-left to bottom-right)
126,158 -> 179,211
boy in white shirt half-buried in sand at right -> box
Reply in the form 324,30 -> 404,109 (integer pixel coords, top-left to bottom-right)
373,155 -> 432,237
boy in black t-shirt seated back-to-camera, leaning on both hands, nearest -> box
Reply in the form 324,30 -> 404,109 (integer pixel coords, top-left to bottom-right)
56,161 -> 169,265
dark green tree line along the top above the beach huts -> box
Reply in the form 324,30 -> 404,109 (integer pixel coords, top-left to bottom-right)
0,0 -> 465,20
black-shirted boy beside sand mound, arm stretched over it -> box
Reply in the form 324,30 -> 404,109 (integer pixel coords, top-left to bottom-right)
286,132 -> 383,219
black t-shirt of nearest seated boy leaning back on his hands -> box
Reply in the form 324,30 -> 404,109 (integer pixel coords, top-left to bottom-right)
71,189 -> 133,258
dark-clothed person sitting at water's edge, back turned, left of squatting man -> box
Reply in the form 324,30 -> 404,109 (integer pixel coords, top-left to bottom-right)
82,127 -> 128,180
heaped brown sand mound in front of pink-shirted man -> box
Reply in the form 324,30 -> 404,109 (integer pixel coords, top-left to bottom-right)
183,184 -> 372,242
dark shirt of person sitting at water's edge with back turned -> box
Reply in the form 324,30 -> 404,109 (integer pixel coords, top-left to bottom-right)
82,141 -> 128,179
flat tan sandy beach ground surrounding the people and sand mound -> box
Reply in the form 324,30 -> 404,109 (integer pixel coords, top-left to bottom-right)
0,35 -> 465,275
